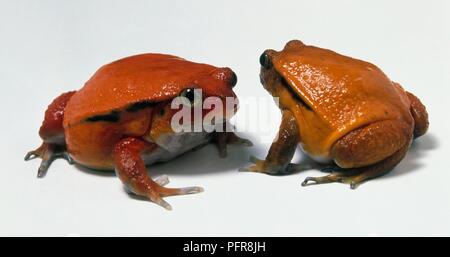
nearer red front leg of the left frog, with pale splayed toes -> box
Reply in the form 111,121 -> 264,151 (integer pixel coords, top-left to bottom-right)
113,137 -> 203,210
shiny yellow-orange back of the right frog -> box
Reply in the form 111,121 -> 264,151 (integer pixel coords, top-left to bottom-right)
274,45 -> 410,131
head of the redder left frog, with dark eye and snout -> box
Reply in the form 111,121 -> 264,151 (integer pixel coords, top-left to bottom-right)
150,65 -> 238,140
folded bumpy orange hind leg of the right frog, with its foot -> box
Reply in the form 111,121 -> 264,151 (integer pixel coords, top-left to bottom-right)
302,120 -> 412,189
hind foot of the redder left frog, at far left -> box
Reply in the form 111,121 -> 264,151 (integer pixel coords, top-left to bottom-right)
24,143 -> 73,178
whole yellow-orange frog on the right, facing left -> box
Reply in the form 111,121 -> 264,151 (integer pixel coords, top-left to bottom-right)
241,40 -> 428,189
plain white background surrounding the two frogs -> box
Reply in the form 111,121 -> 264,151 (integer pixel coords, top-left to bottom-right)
0,0 -> 450,236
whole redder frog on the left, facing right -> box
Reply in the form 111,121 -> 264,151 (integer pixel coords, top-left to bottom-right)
25,54 -> 251,209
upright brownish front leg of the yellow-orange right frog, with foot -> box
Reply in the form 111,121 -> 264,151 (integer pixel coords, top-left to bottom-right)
239,110 -> 300,175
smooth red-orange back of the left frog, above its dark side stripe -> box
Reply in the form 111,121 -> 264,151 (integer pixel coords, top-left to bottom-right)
64,54 -> 215,126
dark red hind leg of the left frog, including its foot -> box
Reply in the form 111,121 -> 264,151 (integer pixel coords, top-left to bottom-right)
25,91 -> 75,178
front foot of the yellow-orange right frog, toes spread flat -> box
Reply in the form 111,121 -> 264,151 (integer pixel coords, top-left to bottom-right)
239,156 -> 314,175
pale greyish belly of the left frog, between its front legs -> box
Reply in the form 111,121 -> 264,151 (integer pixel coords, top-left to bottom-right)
142,132 -> 212,165
